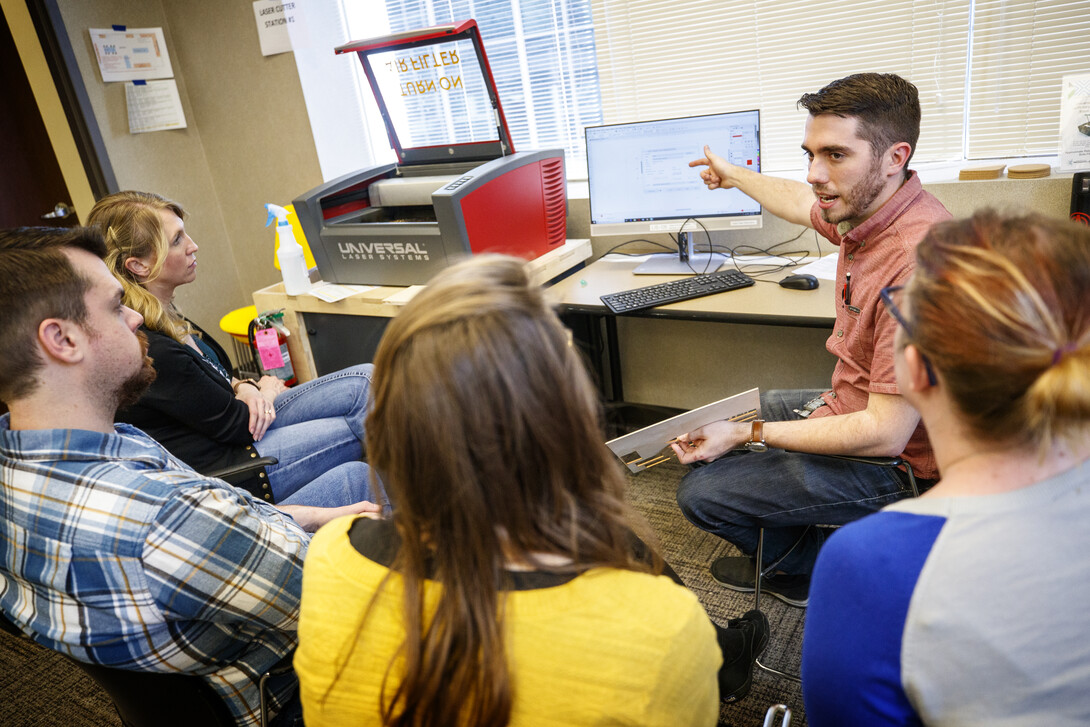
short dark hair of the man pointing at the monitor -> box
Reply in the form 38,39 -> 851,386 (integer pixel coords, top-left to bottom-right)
798,73 -> 920,179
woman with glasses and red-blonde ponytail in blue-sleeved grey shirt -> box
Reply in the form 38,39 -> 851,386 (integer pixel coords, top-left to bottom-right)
802,210 -> 1090,727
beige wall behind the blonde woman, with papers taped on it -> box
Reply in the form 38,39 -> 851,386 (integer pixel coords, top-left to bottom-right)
59,0 -> 322,353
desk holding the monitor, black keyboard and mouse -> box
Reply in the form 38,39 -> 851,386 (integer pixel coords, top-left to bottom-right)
546,255 -> 836,402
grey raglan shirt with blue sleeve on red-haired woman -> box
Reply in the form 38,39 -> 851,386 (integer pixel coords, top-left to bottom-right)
802,460 -> 1090,727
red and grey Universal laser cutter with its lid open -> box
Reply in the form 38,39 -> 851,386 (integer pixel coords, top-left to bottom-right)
293,20 -> 567,286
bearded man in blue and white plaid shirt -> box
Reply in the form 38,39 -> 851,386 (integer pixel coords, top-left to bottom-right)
0,228 -> 378,727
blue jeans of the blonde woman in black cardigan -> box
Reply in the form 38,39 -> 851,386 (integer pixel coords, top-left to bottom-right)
254,364 -> 382,507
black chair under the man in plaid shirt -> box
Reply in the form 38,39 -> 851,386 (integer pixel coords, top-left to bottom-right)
0,613 -> 291,727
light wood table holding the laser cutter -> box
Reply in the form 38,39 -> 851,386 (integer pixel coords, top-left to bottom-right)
254,240 -> 591,381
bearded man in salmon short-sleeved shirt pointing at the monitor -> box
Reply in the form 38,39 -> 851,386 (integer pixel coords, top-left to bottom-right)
673,73 -> 950,606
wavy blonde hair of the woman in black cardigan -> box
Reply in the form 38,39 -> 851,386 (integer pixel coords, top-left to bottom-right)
87,191 -> 194,343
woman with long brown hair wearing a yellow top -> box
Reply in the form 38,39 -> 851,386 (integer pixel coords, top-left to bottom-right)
295,256 -> 741,727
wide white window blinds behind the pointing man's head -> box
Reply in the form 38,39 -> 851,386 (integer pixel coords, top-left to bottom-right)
591,0 -> 1090,171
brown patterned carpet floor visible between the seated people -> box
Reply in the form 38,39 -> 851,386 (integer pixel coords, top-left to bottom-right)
0,463 -> 806,727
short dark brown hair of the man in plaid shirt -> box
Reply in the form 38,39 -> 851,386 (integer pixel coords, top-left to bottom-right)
0,227 -> 106,403
